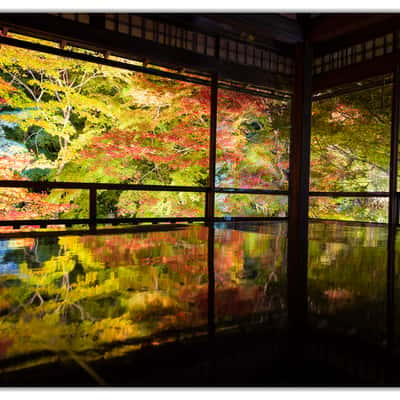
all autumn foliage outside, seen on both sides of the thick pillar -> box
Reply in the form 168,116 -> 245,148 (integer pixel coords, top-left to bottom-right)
0,34 -> 391,222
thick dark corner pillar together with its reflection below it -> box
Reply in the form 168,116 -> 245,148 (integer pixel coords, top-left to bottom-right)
287,41 -> 312,338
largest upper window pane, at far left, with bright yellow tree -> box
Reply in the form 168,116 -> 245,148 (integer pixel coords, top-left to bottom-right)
0,35 -> 210,222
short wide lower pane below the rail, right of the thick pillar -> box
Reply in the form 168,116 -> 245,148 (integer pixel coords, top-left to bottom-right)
308,196 -> 389,222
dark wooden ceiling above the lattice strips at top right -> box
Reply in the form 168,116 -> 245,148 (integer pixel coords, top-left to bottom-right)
139,13 -> 400,54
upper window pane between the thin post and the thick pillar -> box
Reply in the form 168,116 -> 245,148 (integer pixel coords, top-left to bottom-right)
215,89 -> 290,190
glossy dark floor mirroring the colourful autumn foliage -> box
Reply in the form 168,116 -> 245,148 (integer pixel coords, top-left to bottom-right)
0,221 -> 400,386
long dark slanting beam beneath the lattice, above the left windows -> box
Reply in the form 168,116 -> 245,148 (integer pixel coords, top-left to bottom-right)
0,13 -> 291,90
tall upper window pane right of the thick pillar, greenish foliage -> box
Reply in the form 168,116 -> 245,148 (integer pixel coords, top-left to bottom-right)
310,78 -> 392,192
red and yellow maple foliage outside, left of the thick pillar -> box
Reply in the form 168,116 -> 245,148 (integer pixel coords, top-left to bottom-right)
0,33 -> 289,222
